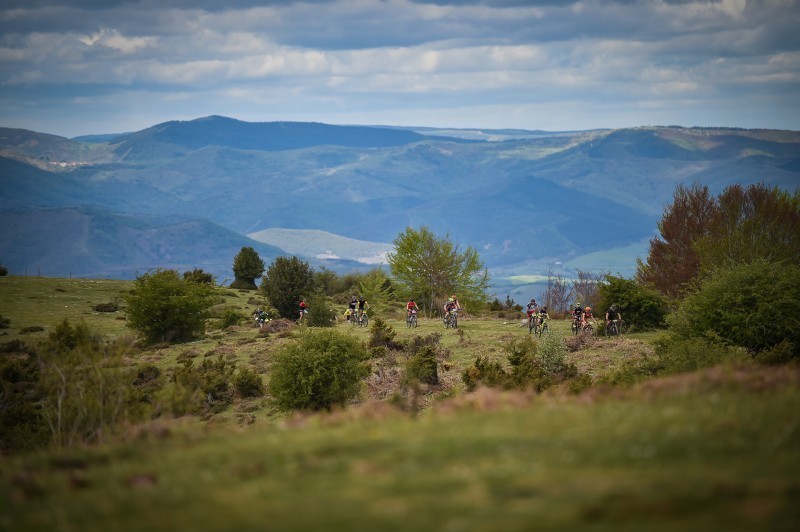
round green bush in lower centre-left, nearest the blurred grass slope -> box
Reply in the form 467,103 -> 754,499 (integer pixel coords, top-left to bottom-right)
269,330 -> 369,410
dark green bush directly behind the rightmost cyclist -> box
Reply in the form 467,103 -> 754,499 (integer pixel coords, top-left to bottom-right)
595,275 -> 668,330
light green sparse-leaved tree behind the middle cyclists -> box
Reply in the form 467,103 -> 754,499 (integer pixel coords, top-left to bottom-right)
388,226 -> 489,316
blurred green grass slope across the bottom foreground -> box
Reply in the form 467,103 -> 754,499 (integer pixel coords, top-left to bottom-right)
0,372 -> 800,530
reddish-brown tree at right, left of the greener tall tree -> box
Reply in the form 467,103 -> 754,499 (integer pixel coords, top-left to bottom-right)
636,184 -> 716,298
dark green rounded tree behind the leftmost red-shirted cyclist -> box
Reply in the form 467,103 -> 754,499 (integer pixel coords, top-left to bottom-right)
261,257 -> 315,319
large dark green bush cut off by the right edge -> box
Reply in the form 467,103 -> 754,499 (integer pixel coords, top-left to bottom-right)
670,261 -> 800,357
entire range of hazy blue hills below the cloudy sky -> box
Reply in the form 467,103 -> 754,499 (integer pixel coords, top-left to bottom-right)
0,117 -> 800,294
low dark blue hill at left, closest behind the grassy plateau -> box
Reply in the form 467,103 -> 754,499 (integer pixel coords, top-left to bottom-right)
0,208 -> 283,282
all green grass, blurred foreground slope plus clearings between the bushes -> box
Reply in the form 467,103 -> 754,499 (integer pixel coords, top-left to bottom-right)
0,277 -> 800,531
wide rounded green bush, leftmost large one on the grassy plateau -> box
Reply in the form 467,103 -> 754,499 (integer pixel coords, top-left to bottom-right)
125,269 -> 215,342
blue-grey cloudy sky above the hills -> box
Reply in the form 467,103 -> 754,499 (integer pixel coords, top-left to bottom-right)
0,0 -> 800,137
